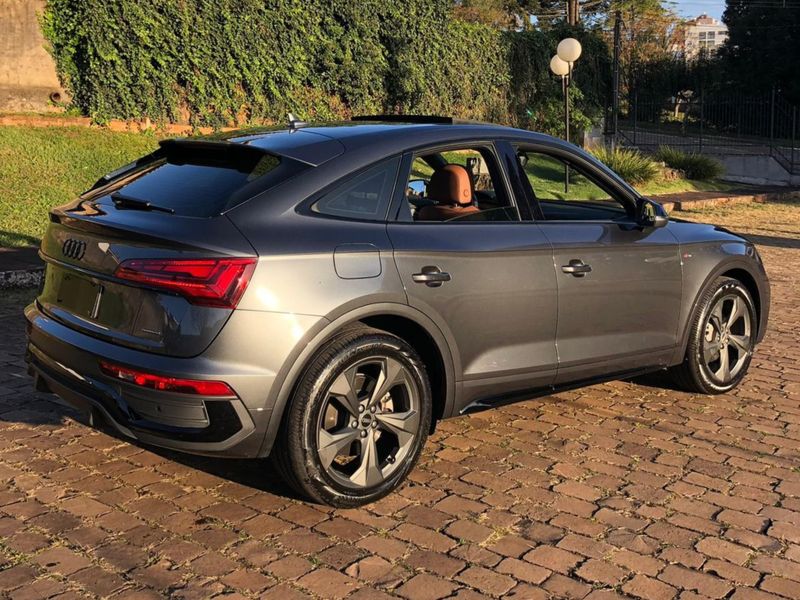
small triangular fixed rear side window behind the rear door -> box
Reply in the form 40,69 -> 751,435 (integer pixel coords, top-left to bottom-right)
311,157 -> 400,221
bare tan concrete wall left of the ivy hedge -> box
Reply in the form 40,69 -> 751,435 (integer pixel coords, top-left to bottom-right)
0,0 -> 65,111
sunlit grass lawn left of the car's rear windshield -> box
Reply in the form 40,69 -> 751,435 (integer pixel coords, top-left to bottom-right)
0,126 -> 157,247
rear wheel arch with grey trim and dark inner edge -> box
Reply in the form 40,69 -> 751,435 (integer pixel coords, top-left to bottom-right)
259,303 -> 456,457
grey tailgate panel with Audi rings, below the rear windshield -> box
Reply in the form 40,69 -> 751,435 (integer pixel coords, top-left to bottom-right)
37,202 -> 255,357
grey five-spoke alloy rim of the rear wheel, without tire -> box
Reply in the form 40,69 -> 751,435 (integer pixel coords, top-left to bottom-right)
317,356 -> 420,489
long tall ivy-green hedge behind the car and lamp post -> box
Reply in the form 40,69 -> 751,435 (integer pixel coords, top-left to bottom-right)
42,0 -> 610,130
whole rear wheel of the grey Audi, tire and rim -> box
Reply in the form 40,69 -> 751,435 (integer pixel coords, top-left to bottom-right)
272,326 -> 432,508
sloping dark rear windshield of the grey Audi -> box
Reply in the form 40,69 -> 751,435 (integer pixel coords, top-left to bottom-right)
97,142 -> 299,217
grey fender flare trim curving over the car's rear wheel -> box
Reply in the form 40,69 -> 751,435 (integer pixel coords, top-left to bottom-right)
258,302 -> 456,457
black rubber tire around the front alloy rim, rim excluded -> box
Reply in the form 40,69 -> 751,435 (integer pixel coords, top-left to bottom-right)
687,277 -> 758,394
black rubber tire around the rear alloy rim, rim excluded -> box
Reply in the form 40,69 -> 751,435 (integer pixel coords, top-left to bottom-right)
289,332 -> 432,506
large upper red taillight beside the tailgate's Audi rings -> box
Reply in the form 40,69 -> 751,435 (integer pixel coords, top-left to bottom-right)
114,258 -> 256,308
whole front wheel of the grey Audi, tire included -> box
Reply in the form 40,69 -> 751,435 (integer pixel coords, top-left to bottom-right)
670,277 -> 758,394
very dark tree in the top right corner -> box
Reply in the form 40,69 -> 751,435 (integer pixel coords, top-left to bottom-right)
721,0 -> 800,102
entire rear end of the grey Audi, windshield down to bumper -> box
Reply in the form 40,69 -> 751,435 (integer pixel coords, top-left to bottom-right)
25,135 -> 320,456
